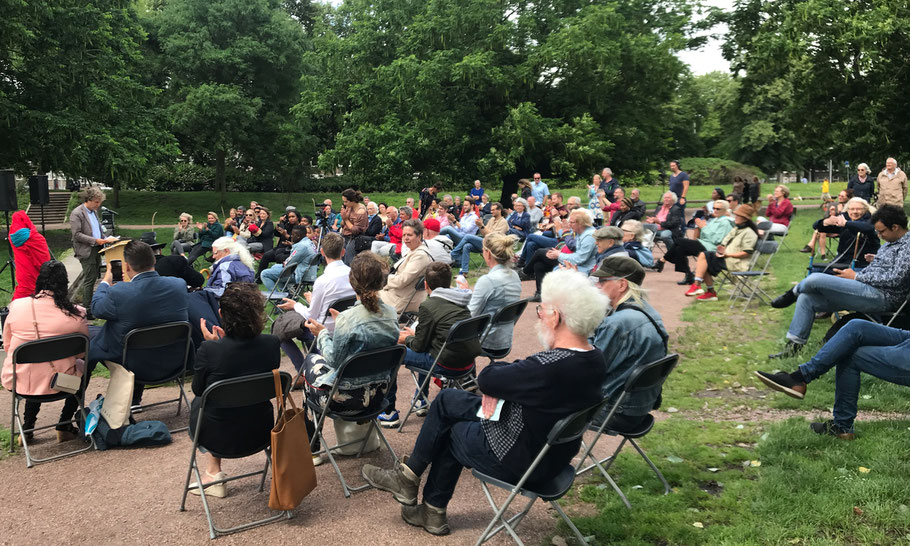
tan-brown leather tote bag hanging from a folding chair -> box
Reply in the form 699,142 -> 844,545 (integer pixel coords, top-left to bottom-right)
269,370 -> 316,510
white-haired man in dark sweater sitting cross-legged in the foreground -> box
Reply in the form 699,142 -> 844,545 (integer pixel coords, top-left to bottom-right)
361,270 -> 607,535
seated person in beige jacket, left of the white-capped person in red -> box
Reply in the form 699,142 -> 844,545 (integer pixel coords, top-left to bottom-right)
379,218 -> 433,314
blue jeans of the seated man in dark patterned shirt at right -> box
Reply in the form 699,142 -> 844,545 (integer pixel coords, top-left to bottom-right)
787,273 -> 891,345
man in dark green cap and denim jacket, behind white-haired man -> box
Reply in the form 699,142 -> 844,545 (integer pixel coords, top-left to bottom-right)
591,256 -> 668,430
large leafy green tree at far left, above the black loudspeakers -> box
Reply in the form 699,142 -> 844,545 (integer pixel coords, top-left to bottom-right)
0,0 -> 177,204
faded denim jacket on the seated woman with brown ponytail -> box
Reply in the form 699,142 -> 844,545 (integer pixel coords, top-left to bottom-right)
314,301 -> 398,390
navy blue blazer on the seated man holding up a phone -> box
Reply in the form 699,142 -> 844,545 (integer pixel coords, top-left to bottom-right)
88,271 -> 187,380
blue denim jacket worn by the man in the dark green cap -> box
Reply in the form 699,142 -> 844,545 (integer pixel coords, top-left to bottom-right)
590,300 -> 667,416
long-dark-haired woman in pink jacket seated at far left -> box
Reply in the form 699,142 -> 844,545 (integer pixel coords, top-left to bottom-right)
0,261 -> 88,443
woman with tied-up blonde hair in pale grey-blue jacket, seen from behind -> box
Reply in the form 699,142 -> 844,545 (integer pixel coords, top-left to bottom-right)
458,233 -> 521,350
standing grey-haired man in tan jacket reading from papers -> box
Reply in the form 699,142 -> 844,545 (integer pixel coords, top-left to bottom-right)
70,186 -> 116,309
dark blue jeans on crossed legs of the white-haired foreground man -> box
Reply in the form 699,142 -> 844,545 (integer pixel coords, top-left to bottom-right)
407,389 -> 525,508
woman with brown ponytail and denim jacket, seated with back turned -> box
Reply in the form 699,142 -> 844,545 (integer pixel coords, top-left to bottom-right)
303,252 -> 399,456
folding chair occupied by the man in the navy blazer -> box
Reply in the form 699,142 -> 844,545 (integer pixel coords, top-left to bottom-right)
120,321 -> 192,433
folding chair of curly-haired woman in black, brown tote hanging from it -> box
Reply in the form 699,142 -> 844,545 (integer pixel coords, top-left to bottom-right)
180,372 -> 293,539
